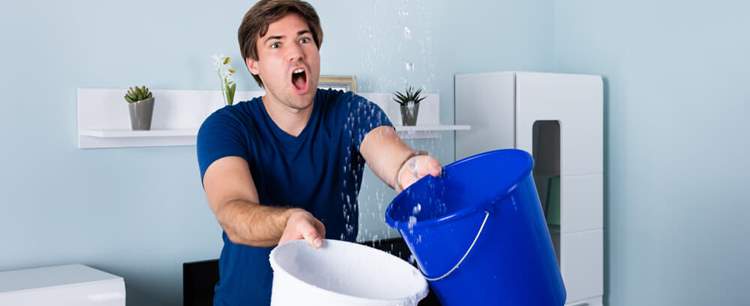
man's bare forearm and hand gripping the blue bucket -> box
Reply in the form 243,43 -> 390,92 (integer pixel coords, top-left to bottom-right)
359,126 -> 442,192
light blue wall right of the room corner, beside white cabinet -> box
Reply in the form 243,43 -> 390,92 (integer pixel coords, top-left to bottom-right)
554,0 -> 750,306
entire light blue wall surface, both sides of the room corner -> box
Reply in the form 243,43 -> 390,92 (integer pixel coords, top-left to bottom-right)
8,0 -> 750,306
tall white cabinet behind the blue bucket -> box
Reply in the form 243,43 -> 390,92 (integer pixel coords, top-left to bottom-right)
455,72 -> 604,306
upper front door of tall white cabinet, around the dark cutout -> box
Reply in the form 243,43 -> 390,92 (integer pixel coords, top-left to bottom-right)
515,72 -> 604,175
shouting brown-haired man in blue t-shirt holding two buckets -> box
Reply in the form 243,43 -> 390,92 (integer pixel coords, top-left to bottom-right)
197,0 -> 442,305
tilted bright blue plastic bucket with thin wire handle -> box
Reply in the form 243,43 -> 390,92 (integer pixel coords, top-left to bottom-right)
385,149 -> 566,306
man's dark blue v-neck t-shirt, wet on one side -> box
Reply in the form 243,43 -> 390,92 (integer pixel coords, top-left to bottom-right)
197,89 -> 391,306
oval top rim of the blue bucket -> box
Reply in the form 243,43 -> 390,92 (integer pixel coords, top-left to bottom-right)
385,149 -> 534,230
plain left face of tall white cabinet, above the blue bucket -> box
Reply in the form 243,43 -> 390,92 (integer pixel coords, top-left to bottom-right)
455,72 -> 515,159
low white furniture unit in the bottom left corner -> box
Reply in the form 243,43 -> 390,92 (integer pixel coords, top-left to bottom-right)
0,264 -> 125,306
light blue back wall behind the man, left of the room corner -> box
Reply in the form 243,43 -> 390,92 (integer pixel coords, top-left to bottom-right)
0,0 -> 553,306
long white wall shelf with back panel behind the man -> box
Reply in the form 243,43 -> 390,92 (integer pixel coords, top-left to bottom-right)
78,88 -> 470,149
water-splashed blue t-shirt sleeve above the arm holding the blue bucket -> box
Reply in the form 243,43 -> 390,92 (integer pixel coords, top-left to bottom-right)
346,93 -> 393,149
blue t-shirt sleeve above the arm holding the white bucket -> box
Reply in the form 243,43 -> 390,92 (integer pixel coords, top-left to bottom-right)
196,109 -> 250,182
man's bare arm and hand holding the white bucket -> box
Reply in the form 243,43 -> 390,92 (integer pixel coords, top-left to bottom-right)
203,156 -> 325,247
